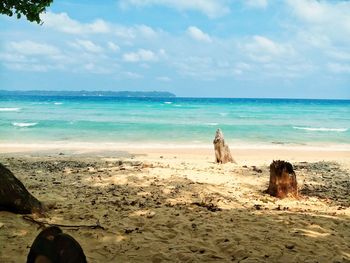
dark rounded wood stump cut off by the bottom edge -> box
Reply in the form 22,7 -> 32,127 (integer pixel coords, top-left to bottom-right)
27,226 -> 87,263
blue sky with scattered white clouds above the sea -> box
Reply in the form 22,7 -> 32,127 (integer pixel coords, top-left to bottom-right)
0,0 -> 350,99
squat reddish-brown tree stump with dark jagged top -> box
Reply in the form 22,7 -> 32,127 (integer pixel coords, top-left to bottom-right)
266,160 -> 298,198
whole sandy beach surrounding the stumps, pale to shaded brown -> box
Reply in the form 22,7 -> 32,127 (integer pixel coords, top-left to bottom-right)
0,147 -> 350,262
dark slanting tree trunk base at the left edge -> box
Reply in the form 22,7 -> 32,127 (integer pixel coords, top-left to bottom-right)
0,163 -> 43,214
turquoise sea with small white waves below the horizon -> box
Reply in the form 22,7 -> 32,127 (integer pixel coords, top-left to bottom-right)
0,96 -> 350,145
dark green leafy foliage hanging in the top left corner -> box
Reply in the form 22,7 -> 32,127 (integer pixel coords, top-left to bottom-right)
0,0 -> 53,24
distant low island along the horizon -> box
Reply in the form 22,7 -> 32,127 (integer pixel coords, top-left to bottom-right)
0,90 -> 176,98
